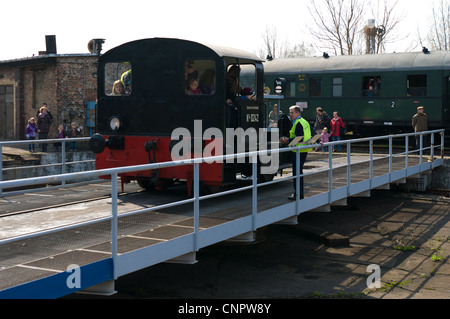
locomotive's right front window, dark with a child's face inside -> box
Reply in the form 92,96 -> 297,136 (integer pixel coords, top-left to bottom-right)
184,59 -> 216,95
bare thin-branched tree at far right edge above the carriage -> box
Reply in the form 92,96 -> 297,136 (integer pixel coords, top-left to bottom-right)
427,0 -> 450,50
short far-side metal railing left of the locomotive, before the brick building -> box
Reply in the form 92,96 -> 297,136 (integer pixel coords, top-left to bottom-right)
0,137 -> 95,196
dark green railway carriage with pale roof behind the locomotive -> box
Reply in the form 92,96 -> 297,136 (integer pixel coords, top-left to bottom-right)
264,50 -> 450,134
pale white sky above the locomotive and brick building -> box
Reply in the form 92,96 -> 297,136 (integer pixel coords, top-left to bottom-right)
0,0 -> 437,61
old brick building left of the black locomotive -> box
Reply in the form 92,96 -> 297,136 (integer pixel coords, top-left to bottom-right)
0,52 -> 98,140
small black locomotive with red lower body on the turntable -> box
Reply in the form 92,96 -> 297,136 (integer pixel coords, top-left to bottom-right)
90,38 -> 264,192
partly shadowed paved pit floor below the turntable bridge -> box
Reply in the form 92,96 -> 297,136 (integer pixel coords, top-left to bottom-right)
96,190 -> 450,307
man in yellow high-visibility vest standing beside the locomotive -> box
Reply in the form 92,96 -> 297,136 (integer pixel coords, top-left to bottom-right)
282,105 -> 316,200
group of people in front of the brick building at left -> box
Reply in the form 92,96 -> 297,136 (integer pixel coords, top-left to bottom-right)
26,103 -> 83,153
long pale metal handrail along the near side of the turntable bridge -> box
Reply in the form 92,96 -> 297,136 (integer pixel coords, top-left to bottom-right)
0,129 -> 444,279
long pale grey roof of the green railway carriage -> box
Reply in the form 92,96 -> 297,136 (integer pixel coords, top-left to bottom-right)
264,51 -> 450,74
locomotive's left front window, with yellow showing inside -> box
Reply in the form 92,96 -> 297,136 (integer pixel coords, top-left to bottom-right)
105,62 -> 131,96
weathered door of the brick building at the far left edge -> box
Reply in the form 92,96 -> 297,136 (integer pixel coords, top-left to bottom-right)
0,85 -> 14,140
